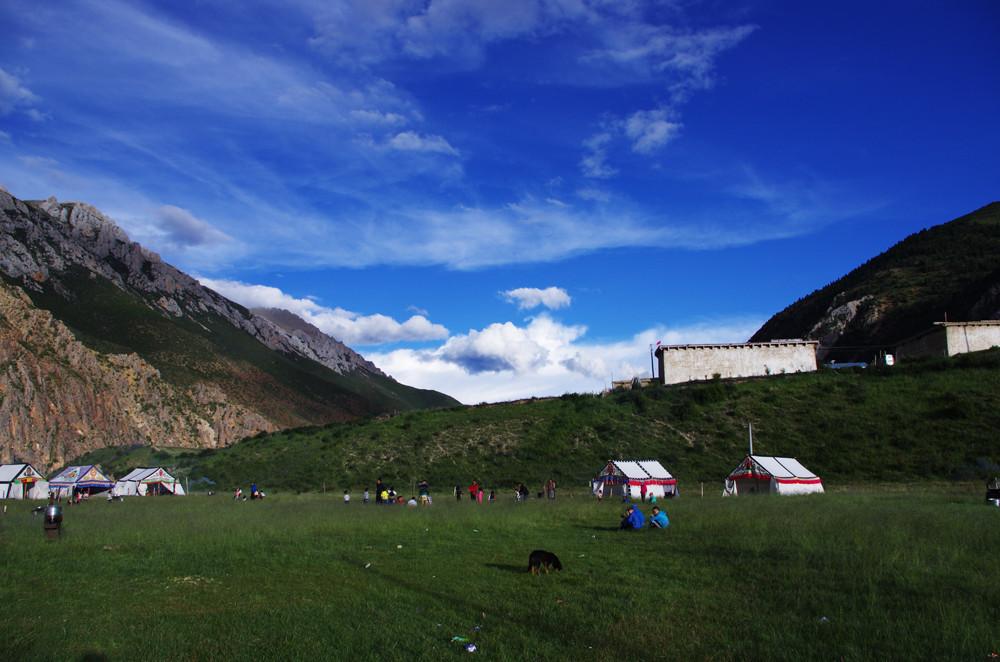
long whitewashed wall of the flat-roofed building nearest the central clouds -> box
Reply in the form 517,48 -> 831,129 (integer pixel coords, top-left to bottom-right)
657,340 -> 819,384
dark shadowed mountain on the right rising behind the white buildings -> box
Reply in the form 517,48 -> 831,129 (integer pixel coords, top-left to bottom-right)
750,202 -> 1000,362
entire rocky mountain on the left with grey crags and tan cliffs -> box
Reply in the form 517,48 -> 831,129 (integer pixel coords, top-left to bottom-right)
0,187 -> 457,468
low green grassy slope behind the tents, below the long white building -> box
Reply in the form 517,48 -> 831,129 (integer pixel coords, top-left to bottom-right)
76,350 -> 1000,493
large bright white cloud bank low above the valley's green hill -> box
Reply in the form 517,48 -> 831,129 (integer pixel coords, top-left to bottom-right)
366,315 -> 763,404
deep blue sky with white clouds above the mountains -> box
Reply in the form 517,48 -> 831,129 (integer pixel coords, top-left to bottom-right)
0,0 -> 1000,403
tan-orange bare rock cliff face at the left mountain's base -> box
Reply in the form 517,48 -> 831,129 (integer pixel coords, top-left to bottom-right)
0,284 -> 277,468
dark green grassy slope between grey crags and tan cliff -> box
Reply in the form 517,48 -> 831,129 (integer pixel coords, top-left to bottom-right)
19,269 -> 455,426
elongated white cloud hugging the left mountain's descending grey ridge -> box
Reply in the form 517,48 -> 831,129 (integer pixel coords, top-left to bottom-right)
198,277 -> 448,346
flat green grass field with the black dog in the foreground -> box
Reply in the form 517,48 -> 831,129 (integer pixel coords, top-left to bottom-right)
0,483 -> 1000,662
